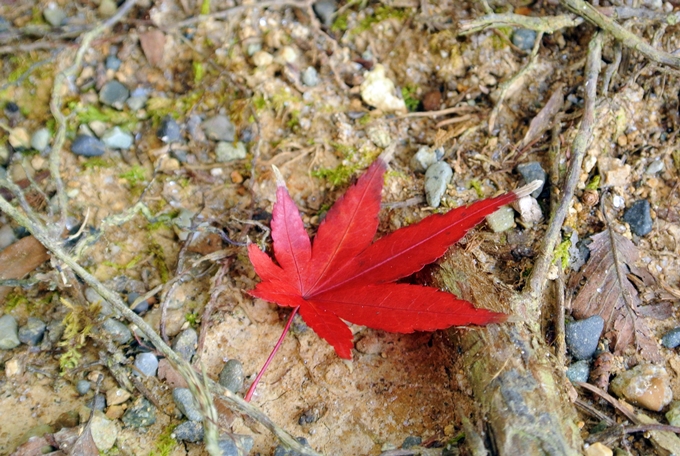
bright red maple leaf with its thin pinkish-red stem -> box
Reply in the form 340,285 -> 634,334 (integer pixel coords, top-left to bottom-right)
246,157 -> 537,400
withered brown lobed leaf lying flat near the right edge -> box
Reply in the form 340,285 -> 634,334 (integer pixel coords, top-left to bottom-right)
569,230 -> 661,361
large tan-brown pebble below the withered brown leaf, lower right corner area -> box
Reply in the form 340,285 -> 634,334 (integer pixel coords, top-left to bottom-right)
610,364 -> 673,412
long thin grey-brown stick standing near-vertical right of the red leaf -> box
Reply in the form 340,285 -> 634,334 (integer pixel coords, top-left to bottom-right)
523,32 -> 604,302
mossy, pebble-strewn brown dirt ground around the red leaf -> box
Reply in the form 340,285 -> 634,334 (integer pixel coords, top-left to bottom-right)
0,0 -> 680,455
